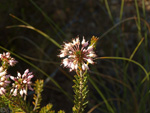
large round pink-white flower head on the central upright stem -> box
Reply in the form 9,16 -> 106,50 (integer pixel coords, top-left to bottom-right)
58,37 -> 96,71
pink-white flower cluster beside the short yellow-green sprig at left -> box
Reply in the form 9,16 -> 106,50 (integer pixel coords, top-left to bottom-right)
10,69 -> 34,96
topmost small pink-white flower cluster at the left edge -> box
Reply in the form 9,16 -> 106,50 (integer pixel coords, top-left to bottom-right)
0,52 -> 17,69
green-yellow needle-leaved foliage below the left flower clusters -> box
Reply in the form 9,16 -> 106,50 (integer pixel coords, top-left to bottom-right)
0,62 -> 64,113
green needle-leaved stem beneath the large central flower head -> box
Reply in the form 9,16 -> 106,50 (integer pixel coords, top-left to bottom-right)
73,75 -> 89,113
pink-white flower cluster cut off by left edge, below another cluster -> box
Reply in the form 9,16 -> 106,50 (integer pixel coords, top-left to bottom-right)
0,67 -> 10,96
